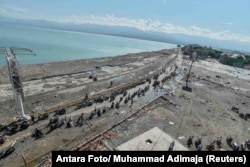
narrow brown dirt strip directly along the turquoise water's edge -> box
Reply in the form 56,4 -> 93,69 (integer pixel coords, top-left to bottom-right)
0,49 -> 175,84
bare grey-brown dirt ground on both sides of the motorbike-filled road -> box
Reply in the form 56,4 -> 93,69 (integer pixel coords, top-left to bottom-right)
0,47 -> 250,166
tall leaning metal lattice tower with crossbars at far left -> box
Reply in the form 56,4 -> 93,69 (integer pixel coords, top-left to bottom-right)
1,48 -> 35,119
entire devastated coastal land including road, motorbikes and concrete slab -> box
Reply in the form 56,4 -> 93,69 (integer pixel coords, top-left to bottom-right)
0,46 -> 250,167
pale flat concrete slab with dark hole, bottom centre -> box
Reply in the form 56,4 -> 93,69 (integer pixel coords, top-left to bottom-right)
116,127 -> 188,151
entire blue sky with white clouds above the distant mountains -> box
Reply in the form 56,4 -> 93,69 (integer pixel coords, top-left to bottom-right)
0,0 -> 250,44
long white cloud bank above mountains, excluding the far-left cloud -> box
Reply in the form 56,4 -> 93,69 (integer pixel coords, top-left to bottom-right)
50,15 -> 250,43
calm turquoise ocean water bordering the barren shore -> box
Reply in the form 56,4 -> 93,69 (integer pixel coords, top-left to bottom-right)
0,25 -> 176,66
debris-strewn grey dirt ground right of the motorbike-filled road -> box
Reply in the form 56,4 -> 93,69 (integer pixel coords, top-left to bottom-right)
108,55 -> 250,150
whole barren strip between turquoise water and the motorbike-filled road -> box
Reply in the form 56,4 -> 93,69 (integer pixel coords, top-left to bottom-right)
0,49 -> 175,118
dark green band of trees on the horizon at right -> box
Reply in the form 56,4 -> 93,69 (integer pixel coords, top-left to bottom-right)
181,44 -> 250,68
